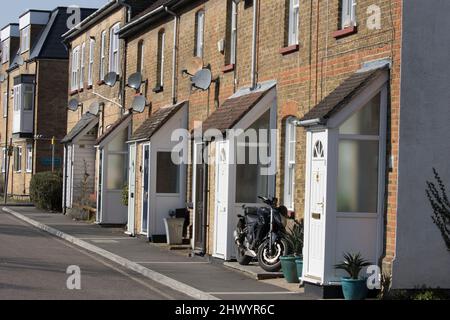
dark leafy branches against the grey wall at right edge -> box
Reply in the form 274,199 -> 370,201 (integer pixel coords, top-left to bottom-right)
426,168 -> 450,251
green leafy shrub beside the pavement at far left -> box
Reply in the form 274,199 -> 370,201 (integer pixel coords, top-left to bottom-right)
30,172 -> 63,212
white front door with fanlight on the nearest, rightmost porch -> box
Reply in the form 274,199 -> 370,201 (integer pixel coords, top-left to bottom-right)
307,131 -> 327,280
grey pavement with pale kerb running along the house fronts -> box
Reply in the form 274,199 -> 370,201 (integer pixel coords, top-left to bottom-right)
0,207 -> 312,300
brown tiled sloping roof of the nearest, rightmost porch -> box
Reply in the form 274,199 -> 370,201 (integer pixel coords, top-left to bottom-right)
300,66 -> 389,126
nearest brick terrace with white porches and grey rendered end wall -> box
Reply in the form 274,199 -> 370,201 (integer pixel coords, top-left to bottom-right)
64,0 -> 450,296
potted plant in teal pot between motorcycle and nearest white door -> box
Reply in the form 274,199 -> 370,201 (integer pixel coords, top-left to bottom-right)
280,220 -> 303,283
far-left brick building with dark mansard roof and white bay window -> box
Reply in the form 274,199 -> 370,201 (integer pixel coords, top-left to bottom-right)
0,7 -> 95,200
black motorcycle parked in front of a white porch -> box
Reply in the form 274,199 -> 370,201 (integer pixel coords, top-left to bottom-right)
234,197 -> 289,272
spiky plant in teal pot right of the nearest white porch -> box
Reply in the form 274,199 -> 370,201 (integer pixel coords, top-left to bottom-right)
334,253 -> 371,300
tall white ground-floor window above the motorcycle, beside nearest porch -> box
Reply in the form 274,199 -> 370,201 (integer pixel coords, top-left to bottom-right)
284,117 -> 297,211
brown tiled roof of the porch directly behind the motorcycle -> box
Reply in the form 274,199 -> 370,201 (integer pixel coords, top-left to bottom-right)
202,81 -> 276,133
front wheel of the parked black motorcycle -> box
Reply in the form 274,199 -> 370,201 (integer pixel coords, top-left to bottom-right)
258,239 -> 289,272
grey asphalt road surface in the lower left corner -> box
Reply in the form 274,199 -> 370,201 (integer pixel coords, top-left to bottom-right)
0,212 -> 189,300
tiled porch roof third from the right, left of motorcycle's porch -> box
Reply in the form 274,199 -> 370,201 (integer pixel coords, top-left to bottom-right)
130,101 -> 187,142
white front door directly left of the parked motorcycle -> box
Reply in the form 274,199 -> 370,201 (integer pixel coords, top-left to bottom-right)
214,141 -> 229,259
